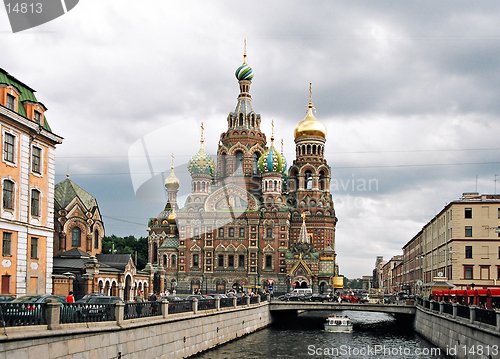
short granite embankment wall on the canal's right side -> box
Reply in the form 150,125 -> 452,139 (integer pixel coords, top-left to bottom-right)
414,306 -> 500,359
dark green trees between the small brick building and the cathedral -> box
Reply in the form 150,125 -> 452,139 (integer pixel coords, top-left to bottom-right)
102,234 -> 148,269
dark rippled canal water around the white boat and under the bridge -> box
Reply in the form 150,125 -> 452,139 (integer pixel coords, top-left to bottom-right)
194,311 -> 449,359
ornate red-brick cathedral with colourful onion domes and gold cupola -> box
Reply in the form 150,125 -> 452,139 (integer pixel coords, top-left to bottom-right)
148,53 -> 338,294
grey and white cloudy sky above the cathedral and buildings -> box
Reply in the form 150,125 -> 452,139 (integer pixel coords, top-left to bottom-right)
0,0 -> 500,278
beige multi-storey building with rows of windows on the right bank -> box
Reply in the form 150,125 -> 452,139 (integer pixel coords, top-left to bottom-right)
403,193 -> 500,290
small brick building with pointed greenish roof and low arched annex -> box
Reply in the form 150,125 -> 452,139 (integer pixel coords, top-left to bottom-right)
53,179 -> 153,301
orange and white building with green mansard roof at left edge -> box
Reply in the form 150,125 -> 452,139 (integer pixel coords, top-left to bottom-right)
0,69 -> 62,295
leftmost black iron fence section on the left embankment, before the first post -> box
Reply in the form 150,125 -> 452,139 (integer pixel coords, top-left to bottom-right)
0,303 -> 47,327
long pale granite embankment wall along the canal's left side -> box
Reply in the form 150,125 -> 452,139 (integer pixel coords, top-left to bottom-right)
0,302 -> 271,359
